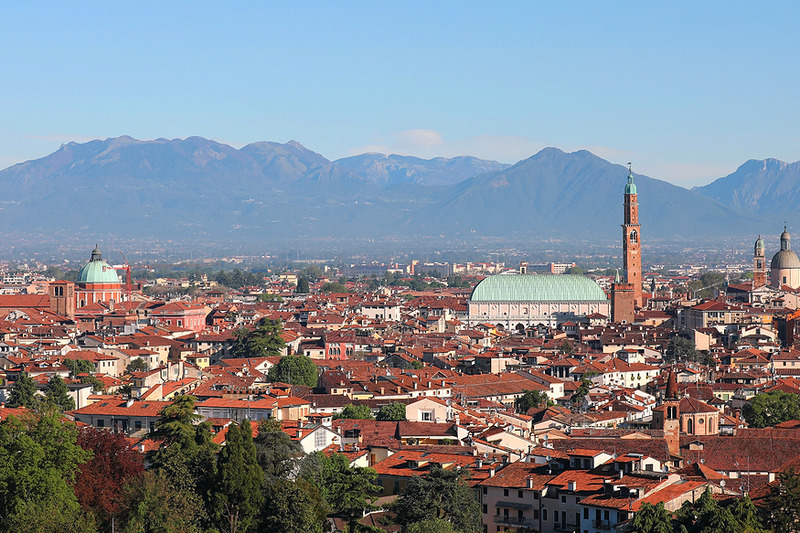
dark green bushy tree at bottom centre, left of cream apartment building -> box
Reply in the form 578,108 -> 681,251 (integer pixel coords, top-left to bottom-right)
389,466 -> 481,533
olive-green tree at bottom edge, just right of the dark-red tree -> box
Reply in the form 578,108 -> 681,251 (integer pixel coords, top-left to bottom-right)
117,471 -> 203,533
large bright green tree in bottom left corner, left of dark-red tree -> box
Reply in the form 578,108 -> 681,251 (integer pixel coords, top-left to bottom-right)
0,415 -> 94,532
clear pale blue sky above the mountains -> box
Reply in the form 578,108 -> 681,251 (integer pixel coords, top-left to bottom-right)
0,1 -> 800,186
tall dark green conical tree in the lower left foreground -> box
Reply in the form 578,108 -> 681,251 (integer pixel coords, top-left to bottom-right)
213,420 -> 264,533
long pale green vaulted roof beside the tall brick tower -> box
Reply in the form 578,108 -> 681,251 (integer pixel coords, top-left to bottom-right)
470,274 -> 608,302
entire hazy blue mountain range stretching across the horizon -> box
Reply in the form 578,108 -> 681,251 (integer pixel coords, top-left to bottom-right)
0,136 -> 800,245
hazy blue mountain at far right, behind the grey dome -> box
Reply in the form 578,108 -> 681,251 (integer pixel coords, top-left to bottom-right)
693,159 -> 800,215
